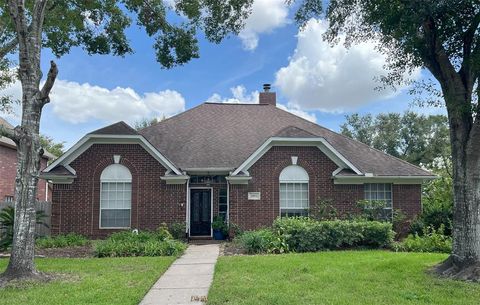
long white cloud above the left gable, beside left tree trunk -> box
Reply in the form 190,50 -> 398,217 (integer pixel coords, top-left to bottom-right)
0,80 -> 185,124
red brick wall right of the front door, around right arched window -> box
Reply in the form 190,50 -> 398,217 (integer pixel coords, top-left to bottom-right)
230,146 -> 421,229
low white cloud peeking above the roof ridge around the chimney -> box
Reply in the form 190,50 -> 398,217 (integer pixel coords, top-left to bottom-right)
205,85 -> 317,123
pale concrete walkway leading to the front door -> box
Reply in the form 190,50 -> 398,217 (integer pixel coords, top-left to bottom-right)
140,244 -> 219,305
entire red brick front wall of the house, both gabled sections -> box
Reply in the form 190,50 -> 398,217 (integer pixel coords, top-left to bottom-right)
52,144 -> 421,238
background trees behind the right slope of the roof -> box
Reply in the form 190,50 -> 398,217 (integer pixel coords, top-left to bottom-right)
340,111 -> 451,168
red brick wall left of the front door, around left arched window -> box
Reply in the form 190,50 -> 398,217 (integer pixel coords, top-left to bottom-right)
52,144 -> 186,238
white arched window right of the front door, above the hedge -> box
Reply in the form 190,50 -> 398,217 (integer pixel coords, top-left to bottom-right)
279,165 -> 309,217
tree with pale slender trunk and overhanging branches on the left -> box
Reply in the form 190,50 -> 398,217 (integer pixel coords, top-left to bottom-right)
0,0 -> 251,281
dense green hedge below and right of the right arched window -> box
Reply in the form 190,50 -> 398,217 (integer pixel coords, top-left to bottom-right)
273,217 -> 395,252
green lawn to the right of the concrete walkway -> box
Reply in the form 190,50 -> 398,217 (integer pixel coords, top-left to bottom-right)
208,251 -> 480,305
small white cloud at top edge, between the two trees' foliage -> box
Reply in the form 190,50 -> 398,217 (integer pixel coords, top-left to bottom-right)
239,0 -> 288,51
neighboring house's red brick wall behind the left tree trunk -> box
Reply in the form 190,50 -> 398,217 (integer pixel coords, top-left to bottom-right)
0,146 -> 52,201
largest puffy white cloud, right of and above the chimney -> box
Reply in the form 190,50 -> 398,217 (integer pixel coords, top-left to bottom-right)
275,19 -> 420,112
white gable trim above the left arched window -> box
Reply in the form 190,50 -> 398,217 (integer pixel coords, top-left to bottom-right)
44,134 -> 182,175
